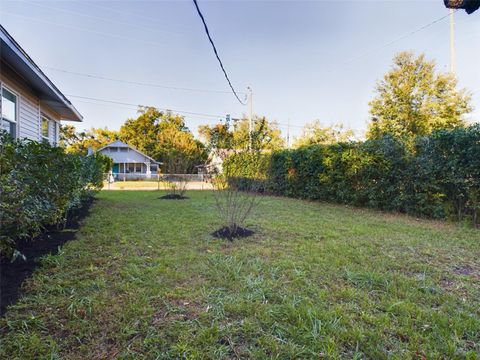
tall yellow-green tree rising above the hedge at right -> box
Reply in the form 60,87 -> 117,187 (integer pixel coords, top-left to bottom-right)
367,52 -> 472,139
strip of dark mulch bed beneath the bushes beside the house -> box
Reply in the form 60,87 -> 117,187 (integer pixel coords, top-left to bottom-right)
0,199 -> 93,315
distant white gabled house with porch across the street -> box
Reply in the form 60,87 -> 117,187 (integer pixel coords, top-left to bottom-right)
97,140 -> 161,180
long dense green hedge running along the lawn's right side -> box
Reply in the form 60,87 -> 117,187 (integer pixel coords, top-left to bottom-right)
224,125 -> 480,223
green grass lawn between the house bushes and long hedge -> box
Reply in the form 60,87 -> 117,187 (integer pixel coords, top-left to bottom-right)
0,191 -> 480,359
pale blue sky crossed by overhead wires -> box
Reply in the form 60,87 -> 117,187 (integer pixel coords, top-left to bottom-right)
0,0 -> 480,136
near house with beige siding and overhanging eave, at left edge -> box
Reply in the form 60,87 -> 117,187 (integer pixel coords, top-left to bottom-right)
0,25 -> 82,145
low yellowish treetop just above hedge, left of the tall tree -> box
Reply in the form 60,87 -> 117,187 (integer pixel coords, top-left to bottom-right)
293,120 -> 354,147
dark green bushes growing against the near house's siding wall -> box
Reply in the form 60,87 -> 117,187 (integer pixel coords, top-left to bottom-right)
0,133 -> 110,257
